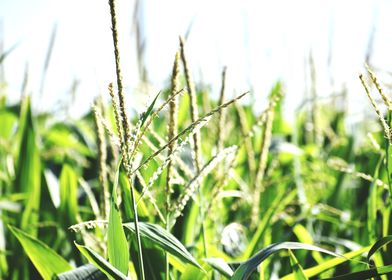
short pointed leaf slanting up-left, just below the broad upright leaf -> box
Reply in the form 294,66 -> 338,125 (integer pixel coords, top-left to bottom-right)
75,243 -> 127,280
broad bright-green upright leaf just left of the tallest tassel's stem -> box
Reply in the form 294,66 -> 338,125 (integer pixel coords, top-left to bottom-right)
108,164 -> 129,275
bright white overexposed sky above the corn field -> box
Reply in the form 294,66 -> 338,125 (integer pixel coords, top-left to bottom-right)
0,0 -> 392,119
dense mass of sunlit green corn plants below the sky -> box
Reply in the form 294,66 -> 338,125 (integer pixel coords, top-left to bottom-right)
0,37 -> 392,280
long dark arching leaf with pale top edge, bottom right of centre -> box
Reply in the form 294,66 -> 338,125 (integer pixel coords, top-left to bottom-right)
231,242 -> 344,280
